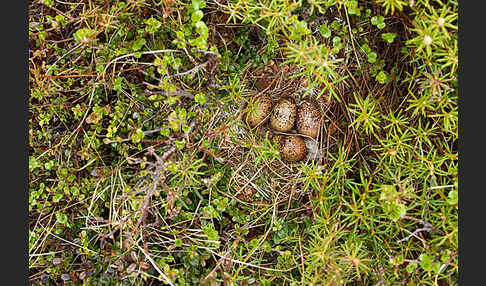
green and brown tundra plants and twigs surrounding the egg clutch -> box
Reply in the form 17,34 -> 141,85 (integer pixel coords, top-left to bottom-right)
28,0 -> 458,285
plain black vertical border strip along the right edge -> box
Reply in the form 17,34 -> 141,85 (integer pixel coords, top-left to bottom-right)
458,1 -> 486,285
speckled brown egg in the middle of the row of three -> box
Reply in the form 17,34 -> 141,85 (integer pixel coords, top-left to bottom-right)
270,98 -> 297,132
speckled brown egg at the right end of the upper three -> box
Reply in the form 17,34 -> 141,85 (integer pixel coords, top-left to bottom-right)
296,101 -> 321,138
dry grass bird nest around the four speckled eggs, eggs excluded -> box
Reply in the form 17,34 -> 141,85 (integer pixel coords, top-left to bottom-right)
213,52 -> 346,204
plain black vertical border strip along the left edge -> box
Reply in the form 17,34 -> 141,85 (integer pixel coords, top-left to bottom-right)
1,1 -> 29,285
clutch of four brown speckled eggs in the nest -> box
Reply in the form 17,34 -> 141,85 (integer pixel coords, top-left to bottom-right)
245,94 -> 321,162
